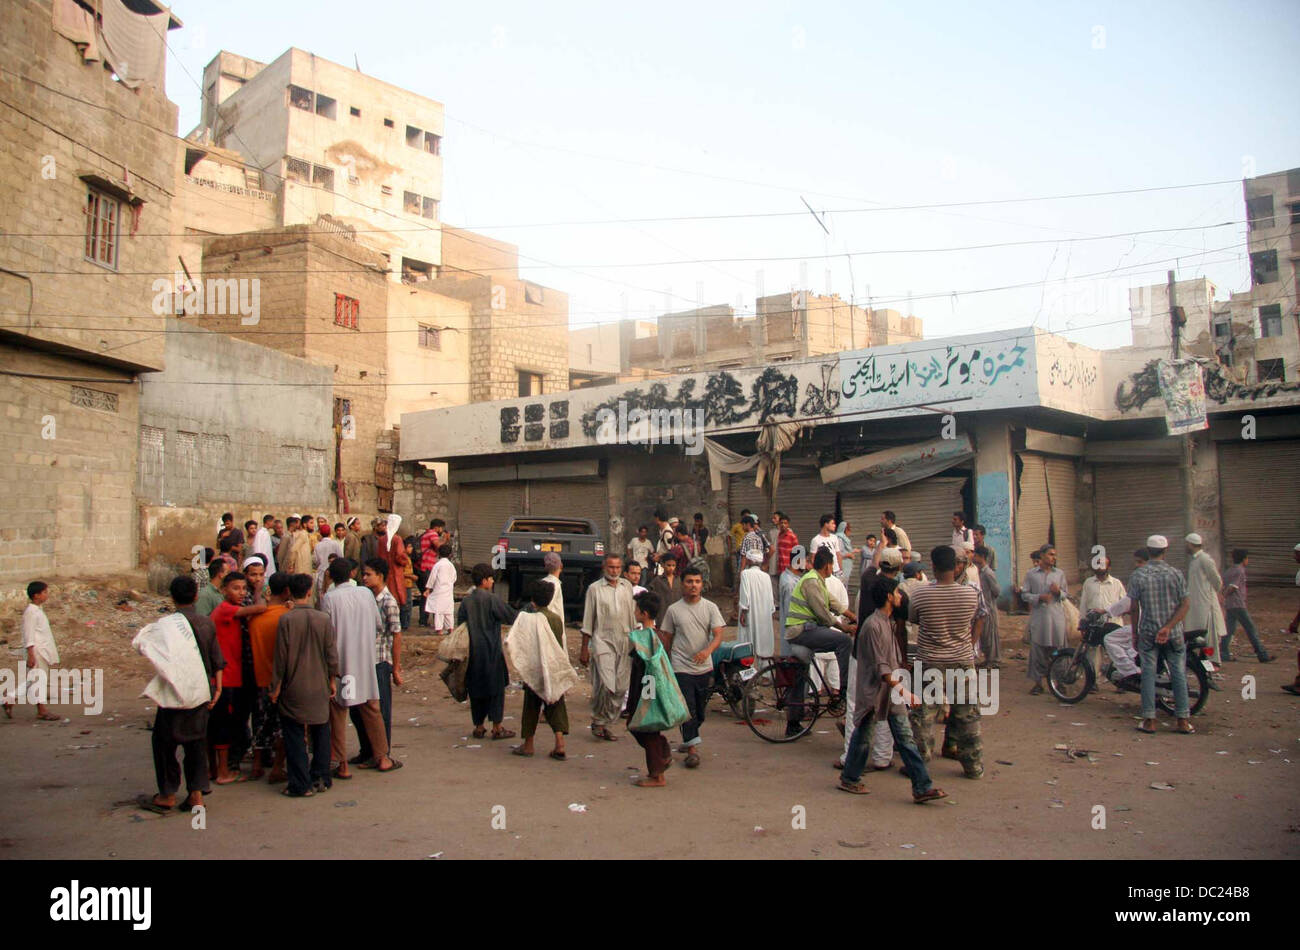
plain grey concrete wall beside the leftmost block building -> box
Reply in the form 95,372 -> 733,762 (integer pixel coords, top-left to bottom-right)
139,318 -> 334,513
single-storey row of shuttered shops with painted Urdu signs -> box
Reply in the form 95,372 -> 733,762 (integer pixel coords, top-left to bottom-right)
402,329 -> 1300,589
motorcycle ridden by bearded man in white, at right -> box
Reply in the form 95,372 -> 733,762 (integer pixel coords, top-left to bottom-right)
1048,611 -> 1214,716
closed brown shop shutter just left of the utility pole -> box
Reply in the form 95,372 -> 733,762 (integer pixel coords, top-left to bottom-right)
1092,464 -> 1187,580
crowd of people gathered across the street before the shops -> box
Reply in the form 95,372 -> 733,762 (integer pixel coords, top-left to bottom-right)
4,509 -> 1300,814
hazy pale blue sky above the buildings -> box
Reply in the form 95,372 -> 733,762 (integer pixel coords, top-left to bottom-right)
168,0 -> 1300,346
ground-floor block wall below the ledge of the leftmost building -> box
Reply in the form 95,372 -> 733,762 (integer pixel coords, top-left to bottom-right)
0,340 -> 139,582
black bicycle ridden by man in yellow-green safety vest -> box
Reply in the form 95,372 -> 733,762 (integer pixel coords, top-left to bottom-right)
737,648 -> 844,742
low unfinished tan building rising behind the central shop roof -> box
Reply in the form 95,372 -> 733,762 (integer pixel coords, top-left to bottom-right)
623,291 -> 922,373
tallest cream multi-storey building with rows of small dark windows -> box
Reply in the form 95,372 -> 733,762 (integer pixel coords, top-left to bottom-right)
187,49 -> 443,281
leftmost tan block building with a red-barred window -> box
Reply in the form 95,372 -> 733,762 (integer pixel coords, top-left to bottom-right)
0,0 -> 181,582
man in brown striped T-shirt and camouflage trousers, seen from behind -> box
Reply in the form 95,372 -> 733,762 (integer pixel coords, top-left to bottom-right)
907,545 -> 984,778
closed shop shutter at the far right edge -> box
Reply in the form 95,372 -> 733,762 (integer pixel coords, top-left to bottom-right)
1218,439 -> 1300,585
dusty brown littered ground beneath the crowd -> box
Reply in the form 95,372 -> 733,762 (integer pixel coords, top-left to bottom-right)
0,577 -> 1300,859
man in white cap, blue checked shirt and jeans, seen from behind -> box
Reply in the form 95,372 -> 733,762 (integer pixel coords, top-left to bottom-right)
1128,534 -> 1196,734
